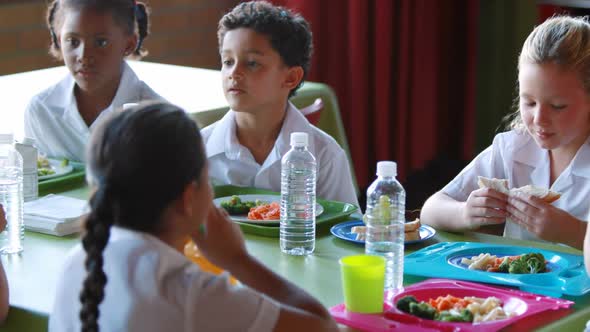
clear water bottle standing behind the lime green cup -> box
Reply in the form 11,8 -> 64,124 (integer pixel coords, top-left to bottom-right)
364,161 -> 406,294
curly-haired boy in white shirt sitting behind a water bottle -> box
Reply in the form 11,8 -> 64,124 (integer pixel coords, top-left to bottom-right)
202,1 -> 358,206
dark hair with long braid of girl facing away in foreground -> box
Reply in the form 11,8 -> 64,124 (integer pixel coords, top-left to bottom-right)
80,103 -> 207,331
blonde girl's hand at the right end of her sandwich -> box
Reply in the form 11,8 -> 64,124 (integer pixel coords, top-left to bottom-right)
508,193 -> 584,248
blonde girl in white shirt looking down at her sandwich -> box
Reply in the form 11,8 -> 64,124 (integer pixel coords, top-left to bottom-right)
421,16 -> 590,249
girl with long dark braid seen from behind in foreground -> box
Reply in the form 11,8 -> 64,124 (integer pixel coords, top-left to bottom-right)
49,103 -> 336,331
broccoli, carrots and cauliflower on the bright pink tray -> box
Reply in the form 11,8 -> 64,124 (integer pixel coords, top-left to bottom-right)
396,295 -> 515,323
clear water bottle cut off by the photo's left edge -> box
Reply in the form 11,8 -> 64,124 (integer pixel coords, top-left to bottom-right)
0,134 -> 25,254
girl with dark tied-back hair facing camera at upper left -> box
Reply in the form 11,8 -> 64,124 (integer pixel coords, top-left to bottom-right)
25,0 -> 162,161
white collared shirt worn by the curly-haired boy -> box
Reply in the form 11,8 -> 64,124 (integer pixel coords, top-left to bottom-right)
201,103 -> 359,206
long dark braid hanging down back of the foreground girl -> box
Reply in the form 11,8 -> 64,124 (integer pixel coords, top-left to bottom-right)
80,186 -> 113,332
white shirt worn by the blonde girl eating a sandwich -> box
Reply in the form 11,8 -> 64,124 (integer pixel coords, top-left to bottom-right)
442,131 -> 590,241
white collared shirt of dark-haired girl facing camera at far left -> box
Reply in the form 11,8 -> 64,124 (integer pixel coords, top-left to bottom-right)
25,62 -> 163,161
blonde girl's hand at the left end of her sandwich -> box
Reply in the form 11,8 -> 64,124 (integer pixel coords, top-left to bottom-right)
463,188 -> 508,229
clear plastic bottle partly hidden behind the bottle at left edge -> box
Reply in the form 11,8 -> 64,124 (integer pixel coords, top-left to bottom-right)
14,137 -> 39,202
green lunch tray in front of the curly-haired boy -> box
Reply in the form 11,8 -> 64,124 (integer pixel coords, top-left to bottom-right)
213,185 -> 358,238
